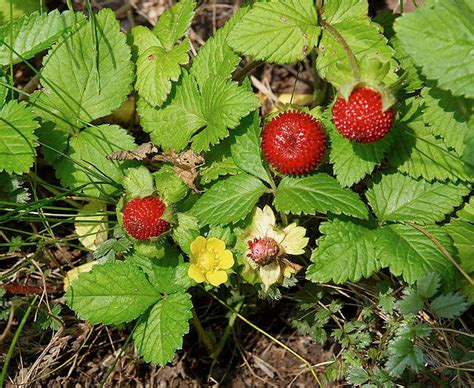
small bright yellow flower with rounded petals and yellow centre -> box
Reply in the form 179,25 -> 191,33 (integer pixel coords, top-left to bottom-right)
188,236 -> 234,286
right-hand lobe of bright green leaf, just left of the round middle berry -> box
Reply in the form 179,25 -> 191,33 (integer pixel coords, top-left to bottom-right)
192,78 -> 259,152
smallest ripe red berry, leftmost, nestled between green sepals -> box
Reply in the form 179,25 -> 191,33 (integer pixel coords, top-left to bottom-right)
123,196 -> 170,240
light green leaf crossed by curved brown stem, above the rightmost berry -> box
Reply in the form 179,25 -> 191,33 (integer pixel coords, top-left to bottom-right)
316,17 -> 396,87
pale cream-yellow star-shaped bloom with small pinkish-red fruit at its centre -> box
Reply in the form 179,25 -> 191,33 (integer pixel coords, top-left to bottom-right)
246,205 -> 309,290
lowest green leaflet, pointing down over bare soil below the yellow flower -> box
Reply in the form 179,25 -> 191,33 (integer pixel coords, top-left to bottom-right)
133,293 -> 193,366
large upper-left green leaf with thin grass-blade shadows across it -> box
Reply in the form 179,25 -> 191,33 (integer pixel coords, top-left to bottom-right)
32,9 -> 132,128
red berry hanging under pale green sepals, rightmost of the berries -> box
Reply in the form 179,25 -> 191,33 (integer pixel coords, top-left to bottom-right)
332,88 -> 393,143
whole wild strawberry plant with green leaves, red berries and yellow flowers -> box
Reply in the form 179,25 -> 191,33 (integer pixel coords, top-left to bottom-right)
0,0 -> 474,384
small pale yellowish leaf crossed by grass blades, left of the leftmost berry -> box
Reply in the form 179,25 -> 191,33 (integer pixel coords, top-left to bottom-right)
74,200 -> 107,251
